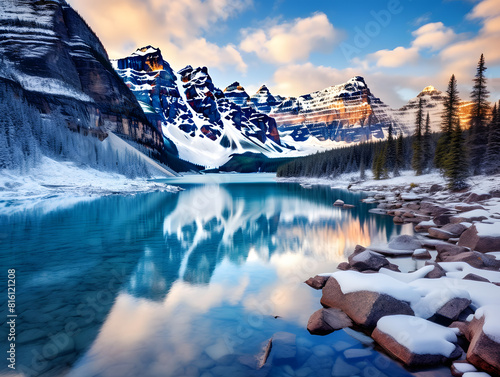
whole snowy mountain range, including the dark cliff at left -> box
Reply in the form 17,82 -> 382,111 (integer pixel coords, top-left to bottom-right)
0,0 -> 484,173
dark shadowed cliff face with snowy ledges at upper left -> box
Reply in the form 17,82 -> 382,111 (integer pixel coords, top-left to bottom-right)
0,0 -> 163,152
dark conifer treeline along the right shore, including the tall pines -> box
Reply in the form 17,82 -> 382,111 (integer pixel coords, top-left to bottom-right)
277,55 -> 500,190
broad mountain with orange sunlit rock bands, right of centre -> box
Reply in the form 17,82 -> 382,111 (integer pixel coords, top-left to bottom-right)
269,76 -> 400,143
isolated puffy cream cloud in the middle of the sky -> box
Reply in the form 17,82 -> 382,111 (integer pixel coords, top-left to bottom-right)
240,13 -> 341,64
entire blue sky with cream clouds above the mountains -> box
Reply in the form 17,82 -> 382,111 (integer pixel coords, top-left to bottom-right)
69,0 -> 500,107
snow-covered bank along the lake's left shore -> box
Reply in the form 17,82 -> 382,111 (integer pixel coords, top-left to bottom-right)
0,157 -> 179,215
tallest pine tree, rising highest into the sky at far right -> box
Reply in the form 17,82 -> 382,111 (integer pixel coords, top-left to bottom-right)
468,54 -> 489,175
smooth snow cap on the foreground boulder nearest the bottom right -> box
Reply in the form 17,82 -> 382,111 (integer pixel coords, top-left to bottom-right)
377,315 -> 458,357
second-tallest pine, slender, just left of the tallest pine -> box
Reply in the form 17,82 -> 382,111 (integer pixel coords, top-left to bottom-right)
434,75 -> 459,169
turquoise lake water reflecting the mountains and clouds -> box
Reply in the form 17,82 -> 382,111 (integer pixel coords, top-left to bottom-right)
0,174 -> 426,377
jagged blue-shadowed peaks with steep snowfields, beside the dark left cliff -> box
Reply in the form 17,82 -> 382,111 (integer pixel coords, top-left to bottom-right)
113,46 -> 293,167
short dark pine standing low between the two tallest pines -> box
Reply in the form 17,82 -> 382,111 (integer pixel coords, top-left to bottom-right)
444,121 -> 469,190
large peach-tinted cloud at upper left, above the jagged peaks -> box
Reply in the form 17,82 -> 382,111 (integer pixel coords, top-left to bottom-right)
69,0 -> 252,72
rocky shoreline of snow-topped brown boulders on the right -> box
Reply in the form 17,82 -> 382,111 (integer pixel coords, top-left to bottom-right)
306,180 -> 500,377
